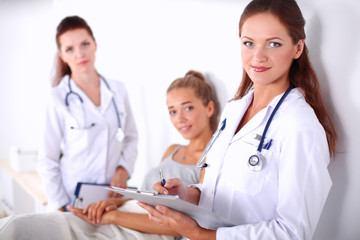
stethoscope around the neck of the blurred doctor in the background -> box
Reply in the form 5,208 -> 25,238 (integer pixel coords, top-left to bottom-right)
65,75 -> 125,142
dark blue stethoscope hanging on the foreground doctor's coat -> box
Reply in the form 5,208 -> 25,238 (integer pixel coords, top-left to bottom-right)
196,83 -> 294,171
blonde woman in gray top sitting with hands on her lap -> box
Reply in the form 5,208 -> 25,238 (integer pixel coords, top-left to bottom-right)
0,71 -> 218,239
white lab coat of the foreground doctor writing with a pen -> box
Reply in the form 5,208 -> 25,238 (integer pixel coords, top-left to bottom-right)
199,88 -> 332,240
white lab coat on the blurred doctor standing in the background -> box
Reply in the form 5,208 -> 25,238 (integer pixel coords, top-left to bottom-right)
38,76 -> 138,210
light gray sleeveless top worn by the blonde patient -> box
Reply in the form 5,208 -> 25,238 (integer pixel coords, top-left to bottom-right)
141,145 -> 200,191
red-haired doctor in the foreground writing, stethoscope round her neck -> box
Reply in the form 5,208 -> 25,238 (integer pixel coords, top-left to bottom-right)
139,0 -> 336,240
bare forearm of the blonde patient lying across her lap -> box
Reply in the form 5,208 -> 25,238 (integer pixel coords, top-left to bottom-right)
107,210 -> 180,236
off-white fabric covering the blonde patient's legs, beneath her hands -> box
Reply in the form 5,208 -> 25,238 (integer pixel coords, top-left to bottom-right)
0,200 -> 174,240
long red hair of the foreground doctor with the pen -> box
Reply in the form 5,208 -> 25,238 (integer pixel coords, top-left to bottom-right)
234,0 -> 337,156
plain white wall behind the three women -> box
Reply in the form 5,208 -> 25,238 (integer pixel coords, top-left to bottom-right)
0,0 -> 360,239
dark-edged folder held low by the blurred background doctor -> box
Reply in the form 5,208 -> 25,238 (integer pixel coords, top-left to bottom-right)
73,182 -> 110,208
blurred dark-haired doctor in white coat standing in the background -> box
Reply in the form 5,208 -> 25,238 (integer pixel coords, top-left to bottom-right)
38,16 -> 138,210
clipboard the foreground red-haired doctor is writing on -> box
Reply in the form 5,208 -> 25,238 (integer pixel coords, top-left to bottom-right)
108,187 -> 236,230
